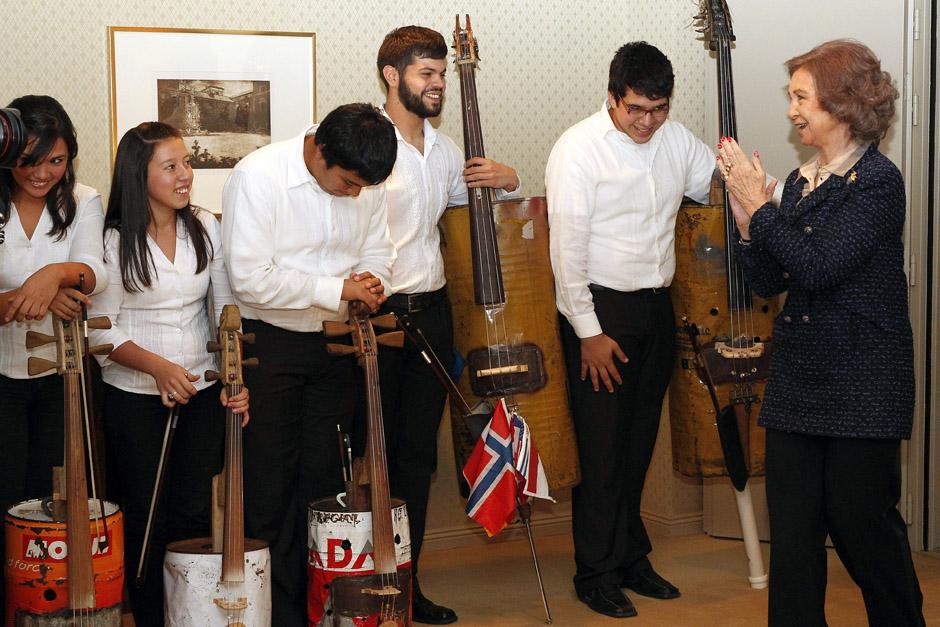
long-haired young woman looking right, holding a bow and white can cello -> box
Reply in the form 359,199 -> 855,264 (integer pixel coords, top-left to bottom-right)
92,122 -> 248,627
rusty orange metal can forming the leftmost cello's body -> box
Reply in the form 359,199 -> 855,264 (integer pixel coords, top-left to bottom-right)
4,499 -> 124,627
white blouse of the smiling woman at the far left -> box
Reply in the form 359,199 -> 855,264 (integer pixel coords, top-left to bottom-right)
0,183 -> 107,379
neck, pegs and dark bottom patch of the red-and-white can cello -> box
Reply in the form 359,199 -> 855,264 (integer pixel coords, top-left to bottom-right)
323,301 -> 411,627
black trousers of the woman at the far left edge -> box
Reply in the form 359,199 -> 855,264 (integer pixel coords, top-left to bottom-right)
0,374 -> 65,616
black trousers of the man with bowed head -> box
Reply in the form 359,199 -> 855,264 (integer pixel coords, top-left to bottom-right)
242,319 -> 355,627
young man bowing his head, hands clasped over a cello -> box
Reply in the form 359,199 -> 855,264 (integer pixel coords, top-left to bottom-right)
222,104 -> 396,627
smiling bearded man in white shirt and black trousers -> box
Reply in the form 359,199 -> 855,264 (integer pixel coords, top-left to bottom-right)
370,26 -> 519,625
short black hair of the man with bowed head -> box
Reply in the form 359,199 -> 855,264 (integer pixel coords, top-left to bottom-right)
315,102 -> 398,185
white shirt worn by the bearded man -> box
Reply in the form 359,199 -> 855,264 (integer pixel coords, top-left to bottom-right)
385,114 -> 521,294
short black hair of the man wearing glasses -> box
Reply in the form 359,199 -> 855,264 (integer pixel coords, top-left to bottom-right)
607,41 -> 675,102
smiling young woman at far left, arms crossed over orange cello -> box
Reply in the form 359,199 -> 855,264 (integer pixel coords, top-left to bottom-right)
0,96 -> 107,620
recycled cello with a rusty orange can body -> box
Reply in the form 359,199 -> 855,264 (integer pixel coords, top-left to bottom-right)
6,317 -> 124,627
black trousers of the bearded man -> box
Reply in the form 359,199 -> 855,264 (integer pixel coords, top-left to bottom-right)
355,298 -> 454,575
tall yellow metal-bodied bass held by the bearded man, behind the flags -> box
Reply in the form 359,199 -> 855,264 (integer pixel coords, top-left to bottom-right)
441,16 -> 580,489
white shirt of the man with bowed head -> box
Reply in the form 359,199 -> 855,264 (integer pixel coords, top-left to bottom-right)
222,125 -> 395,331
